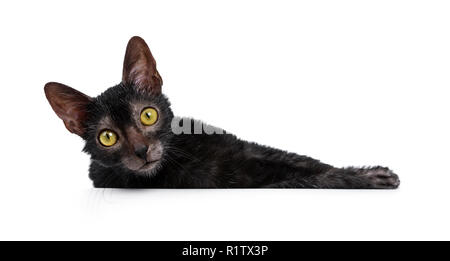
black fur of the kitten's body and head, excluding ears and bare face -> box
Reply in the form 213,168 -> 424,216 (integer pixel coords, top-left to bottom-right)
83,84 -> 399,189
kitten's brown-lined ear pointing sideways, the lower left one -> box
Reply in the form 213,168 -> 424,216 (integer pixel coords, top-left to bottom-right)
44,82 -> 92,137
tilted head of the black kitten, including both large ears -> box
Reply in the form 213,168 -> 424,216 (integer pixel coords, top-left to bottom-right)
44,36 -> 173,174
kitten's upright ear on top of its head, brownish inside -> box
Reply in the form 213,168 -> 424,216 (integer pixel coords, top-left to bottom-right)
122,36 -> 162,94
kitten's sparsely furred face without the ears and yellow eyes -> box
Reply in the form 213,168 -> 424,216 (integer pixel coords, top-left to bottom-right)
84,84 -> 173,174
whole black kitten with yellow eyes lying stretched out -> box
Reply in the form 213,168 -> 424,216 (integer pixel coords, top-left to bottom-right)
44,37 -> 400,189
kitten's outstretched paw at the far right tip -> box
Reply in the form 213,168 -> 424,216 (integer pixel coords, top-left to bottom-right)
361,167 -> 400,189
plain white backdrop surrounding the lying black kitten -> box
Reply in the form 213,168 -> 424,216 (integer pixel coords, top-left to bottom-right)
0,0 -> 450,240
